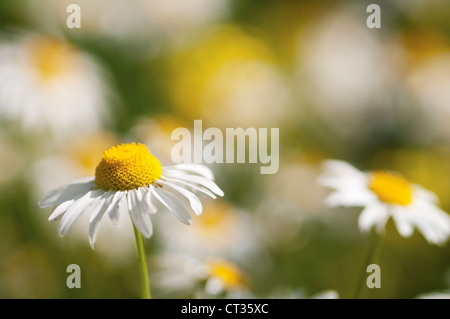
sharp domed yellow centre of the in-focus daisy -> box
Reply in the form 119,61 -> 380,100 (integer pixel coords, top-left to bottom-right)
95,143 -> 162,191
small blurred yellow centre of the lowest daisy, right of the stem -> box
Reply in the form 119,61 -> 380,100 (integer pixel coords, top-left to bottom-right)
206,259 -> 247,289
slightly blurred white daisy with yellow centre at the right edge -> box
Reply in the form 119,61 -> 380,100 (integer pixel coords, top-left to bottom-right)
319,160 -> 450,245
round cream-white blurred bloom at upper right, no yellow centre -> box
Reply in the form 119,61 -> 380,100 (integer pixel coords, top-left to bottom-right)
296,7 -> 396,134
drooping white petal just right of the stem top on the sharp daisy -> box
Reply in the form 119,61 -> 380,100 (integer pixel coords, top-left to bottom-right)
127,190 -> 153,238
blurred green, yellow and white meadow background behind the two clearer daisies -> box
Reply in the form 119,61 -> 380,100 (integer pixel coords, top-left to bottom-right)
0,0 -> 450,298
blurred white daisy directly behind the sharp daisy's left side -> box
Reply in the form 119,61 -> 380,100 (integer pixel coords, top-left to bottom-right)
31,131 -> 139,265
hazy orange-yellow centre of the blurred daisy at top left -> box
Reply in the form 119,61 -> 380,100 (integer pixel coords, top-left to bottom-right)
30,37 -> 75,82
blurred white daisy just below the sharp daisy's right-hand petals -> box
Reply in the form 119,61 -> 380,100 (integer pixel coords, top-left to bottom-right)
158,200 -> 263,266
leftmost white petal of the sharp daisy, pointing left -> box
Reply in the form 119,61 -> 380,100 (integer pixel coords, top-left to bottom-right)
38,178 -> 95,208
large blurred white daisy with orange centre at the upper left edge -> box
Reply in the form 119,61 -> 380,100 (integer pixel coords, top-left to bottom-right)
0,34 -> 108,138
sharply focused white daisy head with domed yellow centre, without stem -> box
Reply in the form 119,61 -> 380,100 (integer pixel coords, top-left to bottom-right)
38,143 -> 224,247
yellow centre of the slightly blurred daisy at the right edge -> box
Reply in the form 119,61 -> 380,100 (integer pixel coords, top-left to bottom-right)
369,171 -> 413,206
